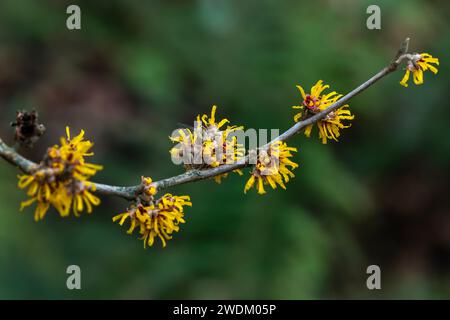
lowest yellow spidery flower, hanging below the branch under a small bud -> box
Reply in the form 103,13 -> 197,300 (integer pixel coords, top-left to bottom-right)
112,193 -> 192,248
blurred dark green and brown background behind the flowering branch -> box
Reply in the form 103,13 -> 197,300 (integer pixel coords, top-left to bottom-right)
0,0 -> 450,299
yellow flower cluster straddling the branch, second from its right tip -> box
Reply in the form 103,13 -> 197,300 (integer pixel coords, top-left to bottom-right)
293,80 -> 355,144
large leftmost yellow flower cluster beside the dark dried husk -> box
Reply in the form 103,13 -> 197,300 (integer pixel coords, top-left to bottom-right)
18,127 -> 102,221
